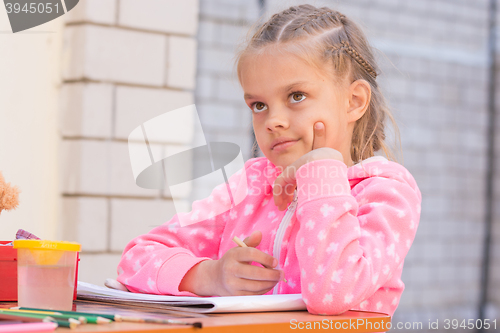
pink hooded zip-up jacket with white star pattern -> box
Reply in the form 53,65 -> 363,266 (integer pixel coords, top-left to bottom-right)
118,156 -> 422,316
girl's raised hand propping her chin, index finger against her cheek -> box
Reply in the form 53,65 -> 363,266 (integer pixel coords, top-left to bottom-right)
273,122 -> 344,210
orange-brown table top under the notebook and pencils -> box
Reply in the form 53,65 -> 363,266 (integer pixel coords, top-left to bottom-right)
0,301 -> 391,333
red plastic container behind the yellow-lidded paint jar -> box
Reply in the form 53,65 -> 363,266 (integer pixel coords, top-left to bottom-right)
0,241 -> 80,302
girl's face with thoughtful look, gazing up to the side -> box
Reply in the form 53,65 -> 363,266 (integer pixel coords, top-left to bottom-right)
239,53 -> 354,168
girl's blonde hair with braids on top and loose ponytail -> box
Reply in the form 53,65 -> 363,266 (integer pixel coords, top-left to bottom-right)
236,5 -> 399,163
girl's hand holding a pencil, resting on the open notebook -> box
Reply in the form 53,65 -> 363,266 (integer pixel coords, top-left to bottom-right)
179,231 -> 283,296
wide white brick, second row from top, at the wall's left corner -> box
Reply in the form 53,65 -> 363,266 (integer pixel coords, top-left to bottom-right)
63,25 -> 166,86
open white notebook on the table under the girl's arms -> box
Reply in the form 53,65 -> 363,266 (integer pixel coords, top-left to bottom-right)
77,281 -> 306,313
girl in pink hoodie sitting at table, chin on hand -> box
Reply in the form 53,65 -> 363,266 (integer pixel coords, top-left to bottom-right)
118,5 -> 421,315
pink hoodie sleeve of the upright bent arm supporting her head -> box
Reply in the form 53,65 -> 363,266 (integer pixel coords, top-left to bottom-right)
296,160 -> 421,315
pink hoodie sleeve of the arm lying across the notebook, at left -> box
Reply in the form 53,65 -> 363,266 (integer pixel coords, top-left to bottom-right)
118,160 -> 252,296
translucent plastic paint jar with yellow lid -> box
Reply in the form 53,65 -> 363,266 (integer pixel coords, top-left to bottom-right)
14,239 -> 81,311
